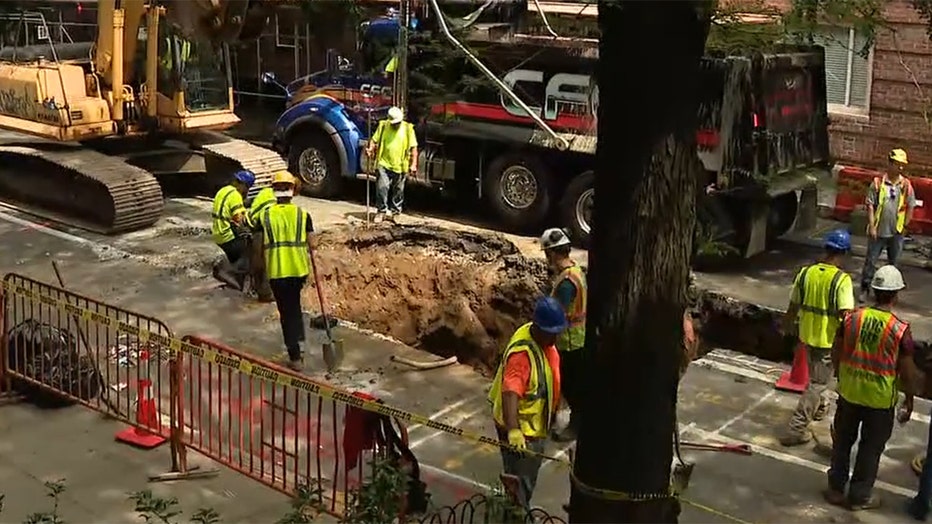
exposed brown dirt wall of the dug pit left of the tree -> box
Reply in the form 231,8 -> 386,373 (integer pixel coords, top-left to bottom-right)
305,226 -> 547,372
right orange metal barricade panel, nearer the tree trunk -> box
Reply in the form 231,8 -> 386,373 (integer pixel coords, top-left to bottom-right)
178,336 -> 372,515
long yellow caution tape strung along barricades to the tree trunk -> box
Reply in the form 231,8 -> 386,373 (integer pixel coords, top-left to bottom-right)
2,281 -> 746,524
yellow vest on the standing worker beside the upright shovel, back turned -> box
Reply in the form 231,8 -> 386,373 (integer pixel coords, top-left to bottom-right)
262,204 -> 311,279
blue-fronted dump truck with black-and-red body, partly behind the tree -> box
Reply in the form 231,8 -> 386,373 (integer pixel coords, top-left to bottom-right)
266,0 -> 829,256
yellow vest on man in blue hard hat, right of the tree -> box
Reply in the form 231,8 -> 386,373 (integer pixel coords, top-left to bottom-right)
794,262 -> 851,349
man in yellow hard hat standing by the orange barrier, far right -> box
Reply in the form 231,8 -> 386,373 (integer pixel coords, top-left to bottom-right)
859,149 -> 916,302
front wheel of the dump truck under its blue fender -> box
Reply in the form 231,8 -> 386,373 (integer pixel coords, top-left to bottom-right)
288,131 -> 343,198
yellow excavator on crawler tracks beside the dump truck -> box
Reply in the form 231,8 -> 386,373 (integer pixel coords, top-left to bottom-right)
0,0 -> 287,234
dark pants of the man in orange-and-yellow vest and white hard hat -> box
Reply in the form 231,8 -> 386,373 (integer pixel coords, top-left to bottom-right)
828,397 -> 893,504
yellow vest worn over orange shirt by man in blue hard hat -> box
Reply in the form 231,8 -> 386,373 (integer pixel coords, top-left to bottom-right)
489,322 -> 554,438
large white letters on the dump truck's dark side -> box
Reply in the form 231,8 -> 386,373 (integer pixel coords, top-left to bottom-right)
501,69 -> 599,120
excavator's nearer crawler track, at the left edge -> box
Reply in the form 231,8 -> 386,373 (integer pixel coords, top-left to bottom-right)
0,140 -> 164,235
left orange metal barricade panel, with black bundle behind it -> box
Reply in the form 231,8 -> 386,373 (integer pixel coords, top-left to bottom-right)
0,273 -> 172,437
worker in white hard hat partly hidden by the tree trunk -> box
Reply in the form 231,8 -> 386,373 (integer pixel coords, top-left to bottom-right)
540,228 -> 588,440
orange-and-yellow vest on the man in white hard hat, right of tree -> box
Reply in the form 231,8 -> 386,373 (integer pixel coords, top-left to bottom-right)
838,307 -> 909,409
